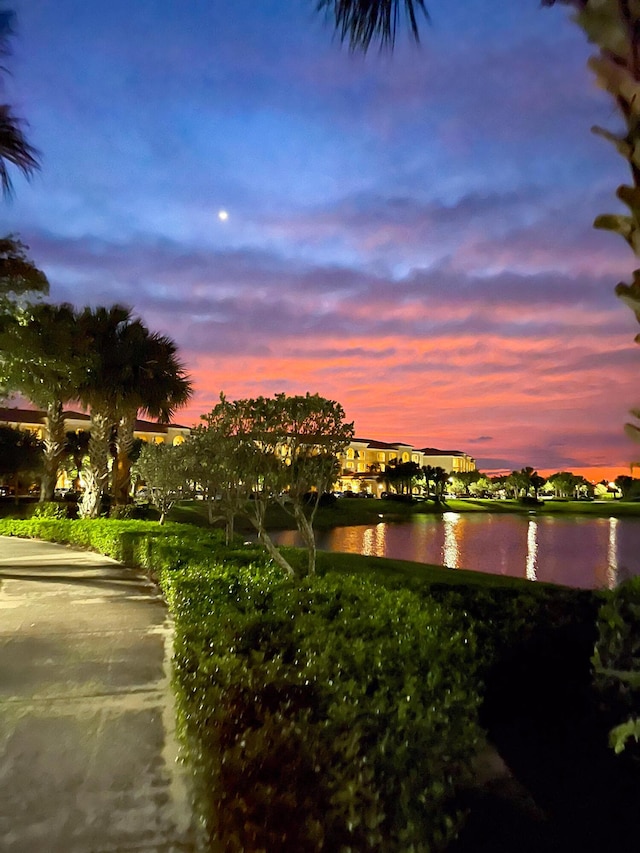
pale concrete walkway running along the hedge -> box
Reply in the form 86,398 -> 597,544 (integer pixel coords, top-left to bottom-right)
0,537 -> 195,853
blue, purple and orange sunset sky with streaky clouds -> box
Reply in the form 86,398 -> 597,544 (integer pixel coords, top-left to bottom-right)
0,0 -> 640,479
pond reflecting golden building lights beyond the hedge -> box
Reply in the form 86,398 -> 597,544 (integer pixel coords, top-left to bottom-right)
274,512 -> 640,589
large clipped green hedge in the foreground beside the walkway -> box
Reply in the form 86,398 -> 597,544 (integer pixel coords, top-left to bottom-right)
162,566 -> 479,851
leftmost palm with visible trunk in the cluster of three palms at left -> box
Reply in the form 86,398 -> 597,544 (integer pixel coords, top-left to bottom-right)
0,302 -> 86,501
